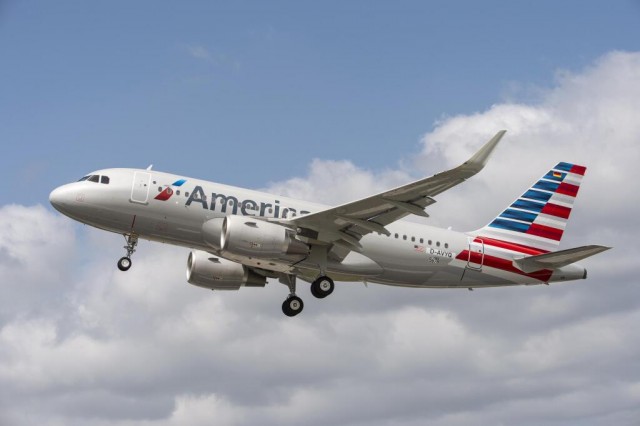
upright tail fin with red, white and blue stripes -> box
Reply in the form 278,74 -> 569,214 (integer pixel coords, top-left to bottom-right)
476,163 -> 587,252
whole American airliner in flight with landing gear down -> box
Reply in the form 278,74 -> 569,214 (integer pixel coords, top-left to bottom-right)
49,130 -> 610,317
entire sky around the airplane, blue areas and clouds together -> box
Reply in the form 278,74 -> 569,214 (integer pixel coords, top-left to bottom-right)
0,1 -> 640,426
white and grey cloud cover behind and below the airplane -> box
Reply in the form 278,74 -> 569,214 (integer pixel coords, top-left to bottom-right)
0,53 -> 640,426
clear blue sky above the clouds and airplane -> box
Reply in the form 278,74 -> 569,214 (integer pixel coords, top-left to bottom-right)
0,1 -> 640,204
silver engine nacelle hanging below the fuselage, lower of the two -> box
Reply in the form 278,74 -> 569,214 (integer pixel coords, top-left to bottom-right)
187,250 -> 267,290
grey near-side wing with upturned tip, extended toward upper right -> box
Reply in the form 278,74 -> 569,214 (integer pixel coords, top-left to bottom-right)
277,130 -> 506,251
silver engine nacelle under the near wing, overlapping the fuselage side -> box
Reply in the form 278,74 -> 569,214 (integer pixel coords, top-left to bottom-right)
220,216 -> 309,260
